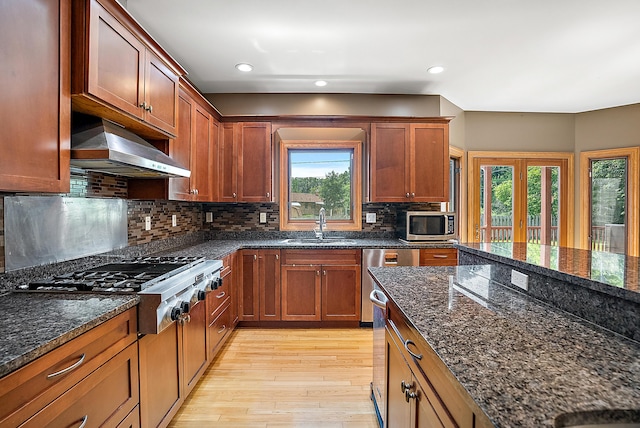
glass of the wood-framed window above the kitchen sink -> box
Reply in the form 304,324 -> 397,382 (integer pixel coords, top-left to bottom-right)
288,149 -> 353,221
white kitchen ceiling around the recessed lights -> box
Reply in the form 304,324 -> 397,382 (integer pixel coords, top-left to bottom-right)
123,0 -> 640,113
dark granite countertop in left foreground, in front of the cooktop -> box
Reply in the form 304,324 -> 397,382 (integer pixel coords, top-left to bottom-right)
0,292 -> 138,377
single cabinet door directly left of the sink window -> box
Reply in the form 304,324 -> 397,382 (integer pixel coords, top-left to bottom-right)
238,122 -> 272,202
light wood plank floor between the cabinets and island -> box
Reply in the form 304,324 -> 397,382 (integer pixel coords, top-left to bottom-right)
169,328 -> 378,428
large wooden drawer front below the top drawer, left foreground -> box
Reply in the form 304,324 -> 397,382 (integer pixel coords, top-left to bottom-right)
20,343 -> 140,428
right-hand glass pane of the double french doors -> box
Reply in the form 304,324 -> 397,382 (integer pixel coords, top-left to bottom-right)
527,166 -> 560,245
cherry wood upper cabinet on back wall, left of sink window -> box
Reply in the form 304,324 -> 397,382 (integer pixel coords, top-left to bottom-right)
219,122 -> 273,202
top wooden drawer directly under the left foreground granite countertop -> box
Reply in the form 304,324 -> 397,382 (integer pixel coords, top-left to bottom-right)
0,308 -> 138,427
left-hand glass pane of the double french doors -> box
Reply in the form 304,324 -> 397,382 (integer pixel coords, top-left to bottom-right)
480,165 -> 513,242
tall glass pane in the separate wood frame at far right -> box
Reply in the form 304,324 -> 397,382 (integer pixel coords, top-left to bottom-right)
591,158 -> 627,254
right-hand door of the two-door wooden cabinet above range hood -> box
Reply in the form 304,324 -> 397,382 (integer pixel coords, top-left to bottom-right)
143,50 -> 178,134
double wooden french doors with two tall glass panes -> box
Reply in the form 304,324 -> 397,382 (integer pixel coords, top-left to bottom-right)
468,152 -> 573,246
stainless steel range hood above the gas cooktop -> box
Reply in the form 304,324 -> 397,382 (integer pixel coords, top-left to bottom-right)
71,118 -> 191,178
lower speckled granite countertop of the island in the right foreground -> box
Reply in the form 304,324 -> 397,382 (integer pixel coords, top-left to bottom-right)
370,265 -> 640,427
